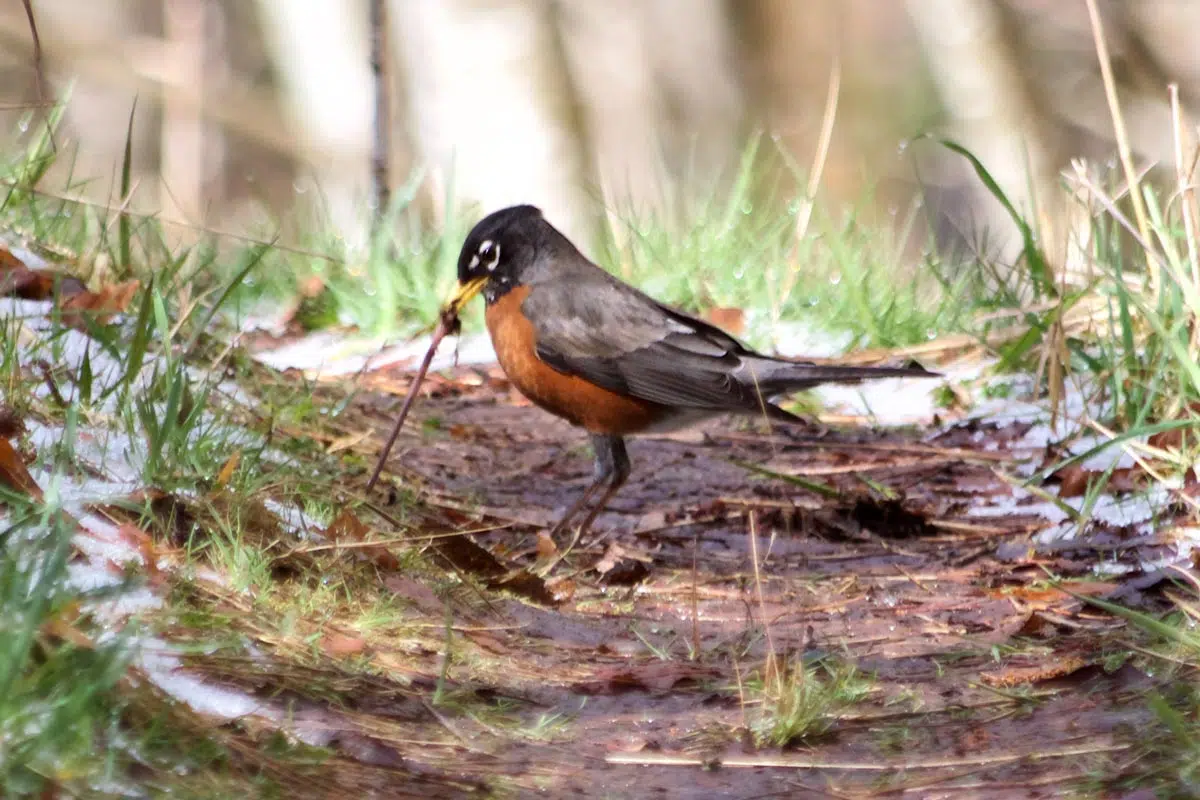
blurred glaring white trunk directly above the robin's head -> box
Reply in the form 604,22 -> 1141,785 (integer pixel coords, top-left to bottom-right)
390,0 -> 590,236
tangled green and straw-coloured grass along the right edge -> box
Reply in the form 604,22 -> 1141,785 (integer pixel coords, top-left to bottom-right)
921,56 -> 1200,796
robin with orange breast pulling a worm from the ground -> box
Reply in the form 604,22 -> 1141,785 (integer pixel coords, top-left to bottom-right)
449,205 -> 936,536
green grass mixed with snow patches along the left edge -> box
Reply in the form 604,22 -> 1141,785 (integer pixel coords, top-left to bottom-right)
0,104 -> 441,796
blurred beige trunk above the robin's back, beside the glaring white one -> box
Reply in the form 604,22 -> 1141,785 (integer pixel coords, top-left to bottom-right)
558,0 -> 743,215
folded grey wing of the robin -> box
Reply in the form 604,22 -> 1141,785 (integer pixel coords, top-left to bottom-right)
522,273 -> 769,411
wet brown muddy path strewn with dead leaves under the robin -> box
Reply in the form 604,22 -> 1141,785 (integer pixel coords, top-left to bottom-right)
328,369 -> 1152,798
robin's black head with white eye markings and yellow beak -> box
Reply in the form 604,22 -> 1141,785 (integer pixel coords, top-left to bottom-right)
449,205 -> 546,314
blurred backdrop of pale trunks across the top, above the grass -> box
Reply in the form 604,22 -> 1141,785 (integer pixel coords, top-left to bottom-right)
0,0 -> 1200,272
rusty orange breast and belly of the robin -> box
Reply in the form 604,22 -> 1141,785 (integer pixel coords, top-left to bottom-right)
485,287 -> 667,435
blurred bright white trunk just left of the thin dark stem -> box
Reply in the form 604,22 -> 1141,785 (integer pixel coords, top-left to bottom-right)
258,0 -> 364,245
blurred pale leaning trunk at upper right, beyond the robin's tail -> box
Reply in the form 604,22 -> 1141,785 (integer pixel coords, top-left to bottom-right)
906,0 -> 1061,268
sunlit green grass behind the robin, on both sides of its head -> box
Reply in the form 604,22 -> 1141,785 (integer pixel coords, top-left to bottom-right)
196,135 -> 974,347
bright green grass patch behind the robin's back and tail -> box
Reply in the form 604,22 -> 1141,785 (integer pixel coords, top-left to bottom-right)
599,140 -> 968,347
